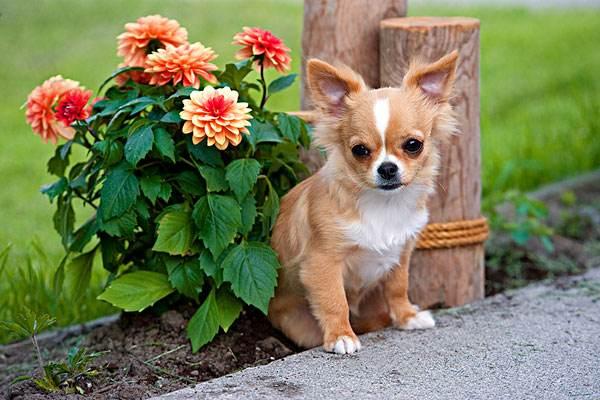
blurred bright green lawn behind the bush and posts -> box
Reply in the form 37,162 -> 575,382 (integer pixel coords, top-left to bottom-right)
0,0 -> 600,342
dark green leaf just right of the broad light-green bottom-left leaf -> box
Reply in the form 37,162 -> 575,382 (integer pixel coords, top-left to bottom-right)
165,257 -> 204,300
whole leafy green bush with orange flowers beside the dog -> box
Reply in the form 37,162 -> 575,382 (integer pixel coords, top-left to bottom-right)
26,15 -> 310,351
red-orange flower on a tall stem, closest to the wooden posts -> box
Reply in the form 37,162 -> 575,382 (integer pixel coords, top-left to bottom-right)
233,27 -> 292,73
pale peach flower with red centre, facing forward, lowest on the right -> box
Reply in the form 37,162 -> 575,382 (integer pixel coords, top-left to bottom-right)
179,86 -> 252,150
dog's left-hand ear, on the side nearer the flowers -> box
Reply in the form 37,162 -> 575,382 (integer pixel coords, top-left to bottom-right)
306,58 -> 366,116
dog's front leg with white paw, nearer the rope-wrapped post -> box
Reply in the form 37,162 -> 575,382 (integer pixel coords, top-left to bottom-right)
383,243 -> 435,329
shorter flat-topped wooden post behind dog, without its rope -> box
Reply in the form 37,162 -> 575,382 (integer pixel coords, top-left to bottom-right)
380,17 -> 484,307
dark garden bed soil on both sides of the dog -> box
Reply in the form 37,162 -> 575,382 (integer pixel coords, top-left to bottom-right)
0,173 -> 600,400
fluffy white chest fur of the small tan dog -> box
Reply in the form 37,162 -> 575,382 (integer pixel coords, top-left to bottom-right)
345,191 -> 428,286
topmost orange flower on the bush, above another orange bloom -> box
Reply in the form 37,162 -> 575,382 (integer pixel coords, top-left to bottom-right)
117,15 -> 187,67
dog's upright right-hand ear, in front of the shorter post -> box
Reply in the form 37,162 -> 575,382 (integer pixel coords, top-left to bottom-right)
403,50 -> 458,103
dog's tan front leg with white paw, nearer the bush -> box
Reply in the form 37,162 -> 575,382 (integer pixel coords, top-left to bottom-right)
300,255 -> 361,354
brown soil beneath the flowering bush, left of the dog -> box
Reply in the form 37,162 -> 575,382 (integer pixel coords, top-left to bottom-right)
0,307 -> 297,400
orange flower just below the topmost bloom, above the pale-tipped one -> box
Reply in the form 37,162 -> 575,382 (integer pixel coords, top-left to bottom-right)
145,43 -> 217,89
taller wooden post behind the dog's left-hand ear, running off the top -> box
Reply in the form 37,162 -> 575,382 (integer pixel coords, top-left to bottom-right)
302,0 -> 406,110
